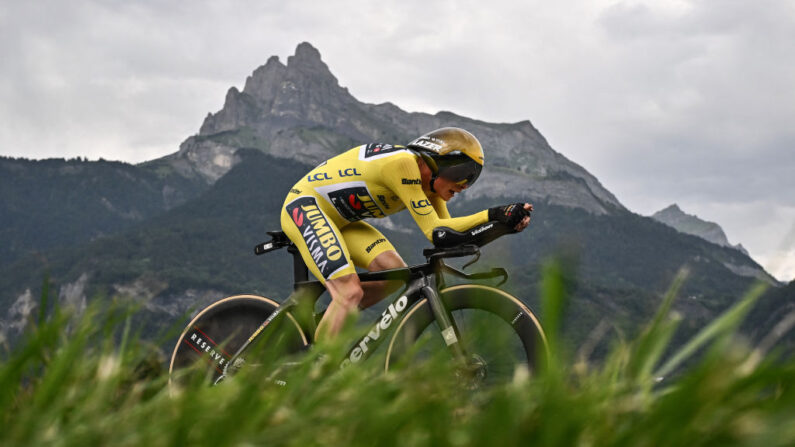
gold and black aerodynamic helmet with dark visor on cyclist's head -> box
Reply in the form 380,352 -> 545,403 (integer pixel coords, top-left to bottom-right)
406,127 -> 483,186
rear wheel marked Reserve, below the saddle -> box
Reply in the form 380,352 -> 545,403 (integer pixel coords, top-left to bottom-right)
168,295 -> 309,384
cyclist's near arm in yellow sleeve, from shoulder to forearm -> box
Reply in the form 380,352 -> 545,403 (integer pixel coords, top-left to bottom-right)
381,157 -> 489,241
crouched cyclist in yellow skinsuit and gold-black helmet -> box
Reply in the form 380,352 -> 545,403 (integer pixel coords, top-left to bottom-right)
281,127 -> 533,339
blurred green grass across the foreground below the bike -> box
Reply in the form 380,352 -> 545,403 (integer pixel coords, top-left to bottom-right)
0,270 -> 795,447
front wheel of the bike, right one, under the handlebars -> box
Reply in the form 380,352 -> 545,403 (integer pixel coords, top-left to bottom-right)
384,284 -> 547,386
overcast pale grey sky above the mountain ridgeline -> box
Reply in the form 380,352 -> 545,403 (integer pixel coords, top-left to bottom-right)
0,0 -> 795,280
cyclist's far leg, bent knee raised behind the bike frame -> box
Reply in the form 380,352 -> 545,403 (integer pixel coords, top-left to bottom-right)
341,221 -> 406,309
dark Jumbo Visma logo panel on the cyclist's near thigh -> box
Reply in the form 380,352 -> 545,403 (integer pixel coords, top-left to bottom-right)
285,197 -> 348,279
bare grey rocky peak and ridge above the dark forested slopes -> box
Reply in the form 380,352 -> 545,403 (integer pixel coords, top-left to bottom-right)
160,43 -> 624,214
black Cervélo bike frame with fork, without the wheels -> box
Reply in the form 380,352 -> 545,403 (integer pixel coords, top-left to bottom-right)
221,244 -> 508,379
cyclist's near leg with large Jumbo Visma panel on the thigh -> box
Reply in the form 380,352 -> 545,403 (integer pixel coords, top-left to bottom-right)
281,198 -> 363,339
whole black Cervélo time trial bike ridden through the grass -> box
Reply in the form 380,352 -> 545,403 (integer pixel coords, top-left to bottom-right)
169,222 -> 547,388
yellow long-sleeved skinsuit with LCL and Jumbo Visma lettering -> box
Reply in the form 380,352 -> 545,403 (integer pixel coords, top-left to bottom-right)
281,143 -> 488,282
